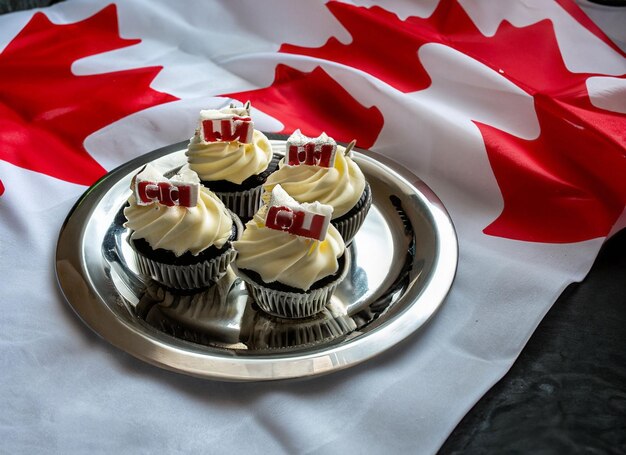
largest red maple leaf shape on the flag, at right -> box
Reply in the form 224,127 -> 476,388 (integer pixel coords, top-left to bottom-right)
277,0 -> 626,242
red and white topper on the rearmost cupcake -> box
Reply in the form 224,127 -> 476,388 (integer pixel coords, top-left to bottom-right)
200,101 -> 254,144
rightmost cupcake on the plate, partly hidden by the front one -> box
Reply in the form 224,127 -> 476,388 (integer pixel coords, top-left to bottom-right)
264,130 -> 372,245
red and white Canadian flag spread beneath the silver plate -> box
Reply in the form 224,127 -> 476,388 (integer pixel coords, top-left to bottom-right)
0,0 -> 626,453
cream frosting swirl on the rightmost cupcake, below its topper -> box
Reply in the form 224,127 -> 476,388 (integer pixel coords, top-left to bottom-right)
263,146 -> 365,218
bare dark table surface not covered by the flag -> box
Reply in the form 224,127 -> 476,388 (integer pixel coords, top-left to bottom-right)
0,0 -> 626,455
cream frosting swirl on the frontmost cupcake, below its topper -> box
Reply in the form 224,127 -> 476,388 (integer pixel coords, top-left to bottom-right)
233,206 -> 345,291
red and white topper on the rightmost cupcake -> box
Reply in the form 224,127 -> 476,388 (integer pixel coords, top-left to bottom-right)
286,129 -> 337,167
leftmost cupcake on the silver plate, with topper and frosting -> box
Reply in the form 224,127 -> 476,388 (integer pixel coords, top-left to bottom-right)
124,164 -> 243,290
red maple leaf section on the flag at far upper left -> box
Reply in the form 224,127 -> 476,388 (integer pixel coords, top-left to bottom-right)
0,5 -> 177,194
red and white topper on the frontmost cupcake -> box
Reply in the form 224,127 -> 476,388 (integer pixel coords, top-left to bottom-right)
265,185 -> 333,240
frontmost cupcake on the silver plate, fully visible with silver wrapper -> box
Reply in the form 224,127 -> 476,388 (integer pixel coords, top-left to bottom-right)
234,185 -> 349,318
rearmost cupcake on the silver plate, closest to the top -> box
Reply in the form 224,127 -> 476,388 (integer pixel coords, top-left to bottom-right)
186,102 -> 278,220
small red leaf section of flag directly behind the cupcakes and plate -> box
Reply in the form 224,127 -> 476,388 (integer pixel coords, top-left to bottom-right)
222,64 -> 383,148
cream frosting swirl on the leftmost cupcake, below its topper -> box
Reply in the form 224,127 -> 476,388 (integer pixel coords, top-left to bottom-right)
124,188 -> 233,256
